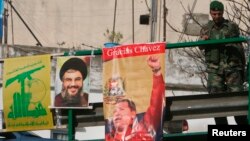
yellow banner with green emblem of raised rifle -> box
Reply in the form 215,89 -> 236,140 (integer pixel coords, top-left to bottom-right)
3,55 -> 53,131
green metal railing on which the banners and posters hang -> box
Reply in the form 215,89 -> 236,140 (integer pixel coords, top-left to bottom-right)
64,37 -> 250,141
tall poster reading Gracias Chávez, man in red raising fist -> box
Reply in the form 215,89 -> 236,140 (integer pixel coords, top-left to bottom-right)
102,43 -> 166,141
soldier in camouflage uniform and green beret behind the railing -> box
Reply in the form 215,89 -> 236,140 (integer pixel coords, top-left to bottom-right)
200,1 -> 247,124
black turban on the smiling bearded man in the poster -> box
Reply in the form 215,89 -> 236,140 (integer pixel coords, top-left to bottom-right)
59,58 -> 88,80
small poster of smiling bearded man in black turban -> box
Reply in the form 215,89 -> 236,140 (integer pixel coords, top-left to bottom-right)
53,56 -> 90,108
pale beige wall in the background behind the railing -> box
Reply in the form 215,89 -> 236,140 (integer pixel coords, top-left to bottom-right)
5,0 -> 246,46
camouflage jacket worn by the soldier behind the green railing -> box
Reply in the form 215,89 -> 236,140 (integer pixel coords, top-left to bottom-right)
200,19 -> 245,69
